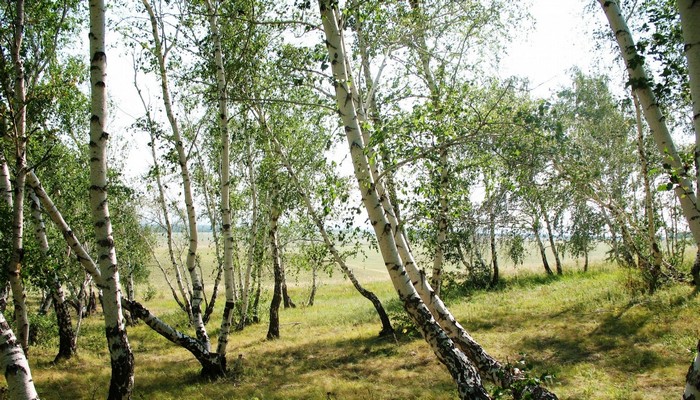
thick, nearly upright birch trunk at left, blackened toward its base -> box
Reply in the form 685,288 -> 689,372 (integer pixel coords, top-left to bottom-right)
89,0 -> 134,400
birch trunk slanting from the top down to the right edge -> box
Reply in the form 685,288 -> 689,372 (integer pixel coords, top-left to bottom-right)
598,0 -> 700,244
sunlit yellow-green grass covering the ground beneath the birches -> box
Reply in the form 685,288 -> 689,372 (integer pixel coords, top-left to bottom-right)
21,236 -> 700,399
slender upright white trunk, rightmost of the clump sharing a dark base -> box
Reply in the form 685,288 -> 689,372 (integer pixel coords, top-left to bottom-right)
206,0 -> 236,358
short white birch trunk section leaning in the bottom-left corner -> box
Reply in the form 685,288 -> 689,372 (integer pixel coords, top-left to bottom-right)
0,313 -> 39,400
